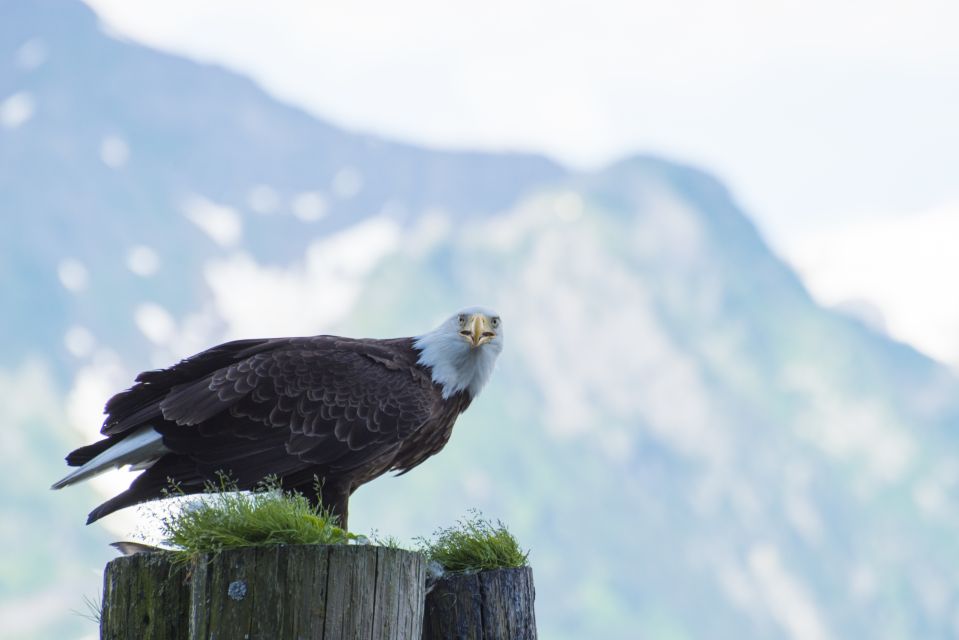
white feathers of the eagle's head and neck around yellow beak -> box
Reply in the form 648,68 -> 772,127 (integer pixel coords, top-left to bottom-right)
413,307 -> 503,398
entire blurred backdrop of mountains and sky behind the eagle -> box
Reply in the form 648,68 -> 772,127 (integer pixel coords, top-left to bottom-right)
0,0 -> 959,640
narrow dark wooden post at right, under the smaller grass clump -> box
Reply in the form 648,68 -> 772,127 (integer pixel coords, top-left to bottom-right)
422,567 -> 536,640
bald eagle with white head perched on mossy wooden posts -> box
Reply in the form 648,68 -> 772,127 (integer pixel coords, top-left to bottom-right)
52,307 -> 503,528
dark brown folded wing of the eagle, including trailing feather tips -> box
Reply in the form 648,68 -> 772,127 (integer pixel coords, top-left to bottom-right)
85,336 -> 443,522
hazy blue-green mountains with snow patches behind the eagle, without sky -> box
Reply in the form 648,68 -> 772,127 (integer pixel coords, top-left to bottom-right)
0,0 -> 959,638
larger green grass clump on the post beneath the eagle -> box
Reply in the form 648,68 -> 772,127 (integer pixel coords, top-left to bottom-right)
160,476 -> 358,558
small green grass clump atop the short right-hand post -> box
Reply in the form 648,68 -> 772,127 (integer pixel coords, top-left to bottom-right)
419,511 -> 529,573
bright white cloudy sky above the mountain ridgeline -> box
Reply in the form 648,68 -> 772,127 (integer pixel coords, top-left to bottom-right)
80,0 -> 959,363
